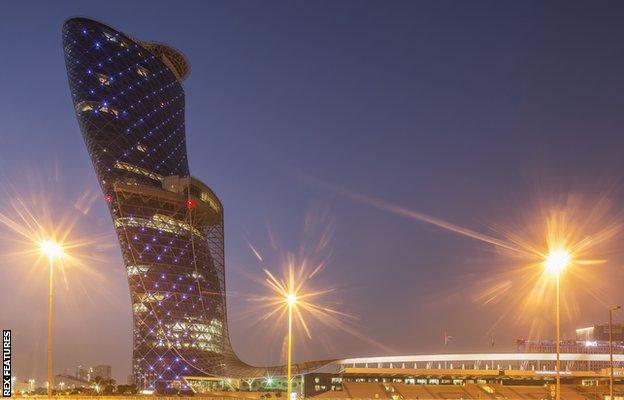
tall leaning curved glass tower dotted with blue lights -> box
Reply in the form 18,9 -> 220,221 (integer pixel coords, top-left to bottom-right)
63,18 -> 332,388
